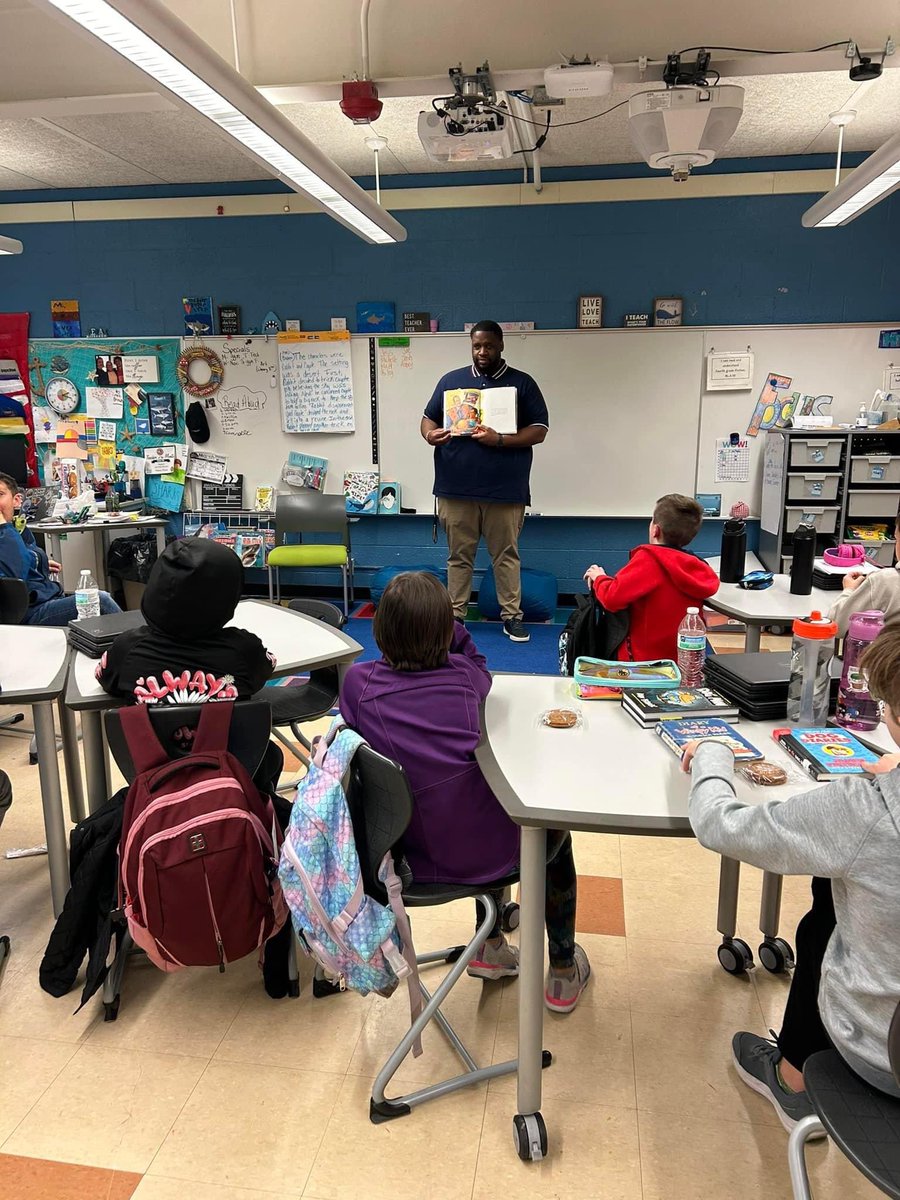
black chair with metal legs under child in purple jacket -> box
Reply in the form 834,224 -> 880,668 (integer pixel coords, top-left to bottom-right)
347,745 -> 551,1128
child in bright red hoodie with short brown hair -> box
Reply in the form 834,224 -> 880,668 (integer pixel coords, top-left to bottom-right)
584,493 -> 719,662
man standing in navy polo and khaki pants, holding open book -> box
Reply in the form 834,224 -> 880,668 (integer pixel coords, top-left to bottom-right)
421,320 -> 548,642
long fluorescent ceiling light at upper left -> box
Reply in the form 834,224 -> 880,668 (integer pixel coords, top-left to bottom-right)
38,0 -> 407,245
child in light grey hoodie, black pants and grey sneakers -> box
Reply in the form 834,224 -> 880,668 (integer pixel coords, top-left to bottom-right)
683,623 -> 900,1130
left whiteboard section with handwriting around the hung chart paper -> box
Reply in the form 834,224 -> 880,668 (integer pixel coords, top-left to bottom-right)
184,335 -> 372,509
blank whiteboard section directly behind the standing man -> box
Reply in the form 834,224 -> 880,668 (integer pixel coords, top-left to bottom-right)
378,328 -> 703,517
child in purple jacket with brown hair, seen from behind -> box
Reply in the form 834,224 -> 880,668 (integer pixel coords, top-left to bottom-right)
341,571 -> 590,1013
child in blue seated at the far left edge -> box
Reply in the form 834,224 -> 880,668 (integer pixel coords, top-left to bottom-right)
0,472 -> 120,625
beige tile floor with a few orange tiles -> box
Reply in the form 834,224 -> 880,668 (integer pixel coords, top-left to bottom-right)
0,635 -> 880,1200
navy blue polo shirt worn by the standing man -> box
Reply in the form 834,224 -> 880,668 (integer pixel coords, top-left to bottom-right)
425,361 -> 550,504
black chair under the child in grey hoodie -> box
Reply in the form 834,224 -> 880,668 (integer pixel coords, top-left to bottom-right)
787,1004 -> 900,1200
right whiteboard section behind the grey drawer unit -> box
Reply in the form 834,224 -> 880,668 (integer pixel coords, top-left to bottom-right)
696,322 -> 899,516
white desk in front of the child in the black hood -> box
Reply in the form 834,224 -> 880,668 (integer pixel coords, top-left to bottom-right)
64,600 -> 362,811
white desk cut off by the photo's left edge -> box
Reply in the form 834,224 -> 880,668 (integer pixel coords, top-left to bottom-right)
0,625 -> 77,916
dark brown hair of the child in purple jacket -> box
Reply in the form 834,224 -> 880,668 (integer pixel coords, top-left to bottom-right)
372,571 -> 454,671
